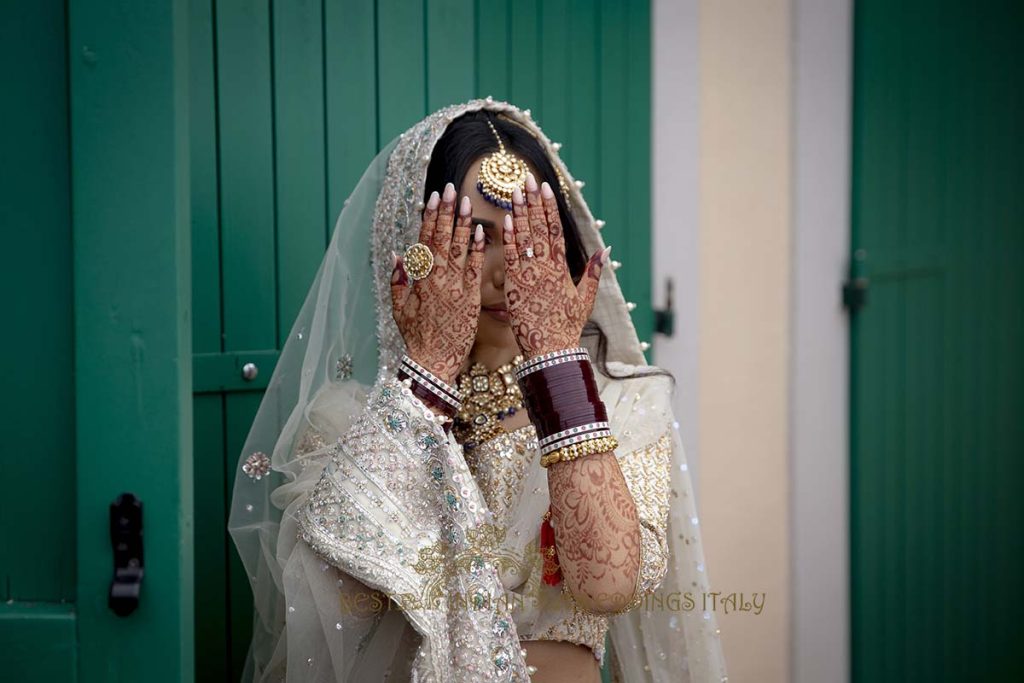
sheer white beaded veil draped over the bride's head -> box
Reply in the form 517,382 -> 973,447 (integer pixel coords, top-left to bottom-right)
228,98 -> 725,683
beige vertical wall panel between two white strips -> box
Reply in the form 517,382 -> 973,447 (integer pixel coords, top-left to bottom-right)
697,0 -> 792,683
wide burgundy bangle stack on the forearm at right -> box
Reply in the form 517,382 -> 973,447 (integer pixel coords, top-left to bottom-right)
519,360 -> 608,439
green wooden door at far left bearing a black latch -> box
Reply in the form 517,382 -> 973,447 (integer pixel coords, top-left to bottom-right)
0,0 -> 195,683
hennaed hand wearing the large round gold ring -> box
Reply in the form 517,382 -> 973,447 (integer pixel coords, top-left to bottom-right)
391,182 -> 484,384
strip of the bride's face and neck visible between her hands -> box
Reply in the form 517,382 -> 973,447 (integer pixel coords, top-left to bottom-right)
459,159 -> 538,352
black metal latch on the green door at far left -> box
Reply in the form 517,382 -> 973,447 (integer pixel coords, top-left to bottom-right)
106,493 -> 143,616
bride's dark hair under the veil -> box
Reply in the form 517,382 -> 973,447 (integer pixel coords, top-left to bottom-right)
423,110 -> 675,382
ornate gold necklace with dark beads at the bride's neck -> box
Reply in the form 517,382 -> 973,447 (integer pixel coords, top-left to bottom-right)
452,355 -> 523,451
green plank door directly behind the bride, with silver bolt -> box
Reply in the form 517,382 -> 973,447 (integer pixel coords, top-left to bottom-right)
189,0 -> 653,681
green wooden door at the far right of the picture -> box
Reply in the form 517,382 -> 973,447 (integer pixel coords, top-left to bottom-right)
851,0 -> 1024,683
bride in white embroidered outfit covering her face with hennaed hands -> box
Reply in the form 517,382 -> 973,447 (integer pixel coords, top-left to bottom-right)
228,98 -> 726,683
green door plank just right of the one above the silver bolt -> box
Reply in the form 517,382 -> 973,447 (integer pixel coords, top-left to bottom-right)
273,0 -> 327,347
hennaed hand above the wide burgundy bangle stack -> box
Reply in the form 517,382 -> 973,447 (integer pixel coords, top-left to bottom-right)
502,174 -> 611,357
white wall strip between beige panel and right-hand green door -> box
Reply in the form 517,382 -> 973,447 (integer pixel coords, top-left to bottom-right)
790,0 -> 852,683
